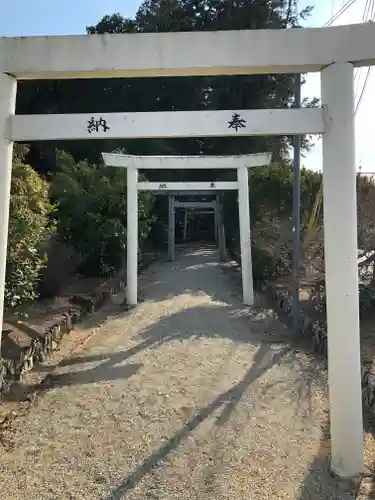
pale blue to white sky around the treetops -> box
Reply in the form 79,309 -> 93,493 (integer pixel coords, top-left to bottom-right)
0,0 -> 375,172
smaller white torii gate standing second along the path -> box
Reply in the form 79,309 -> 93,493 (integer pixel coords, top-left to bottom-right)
102,153 -> 272,305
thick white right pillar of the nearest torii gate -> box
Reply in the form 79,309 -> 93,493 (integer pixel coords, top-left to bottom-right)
321,63 -> 364,477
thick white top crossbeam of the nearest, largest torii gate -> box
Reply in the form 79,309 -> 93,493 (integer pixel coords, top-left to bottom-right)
0,23 -> 375,79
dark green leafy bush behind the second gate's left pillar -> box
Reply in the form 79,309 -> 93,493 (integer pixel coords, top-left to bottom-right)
51,153 -> 153,276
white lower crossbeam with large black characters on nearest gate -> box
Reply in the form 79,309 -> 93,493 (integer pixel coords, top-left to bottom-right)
6,108 -> 325,141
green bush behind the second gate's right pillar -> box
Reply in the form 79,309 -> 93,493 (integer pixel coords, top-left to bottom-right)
224,162 -> 321,284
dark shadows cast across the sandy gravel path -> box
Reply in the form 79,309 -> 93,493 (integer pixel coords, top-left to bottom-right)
5,244 -> 334,500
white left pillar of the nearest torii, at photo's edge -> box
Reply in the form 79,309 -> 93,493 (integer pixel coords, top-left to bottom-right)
0,74 -> 17,354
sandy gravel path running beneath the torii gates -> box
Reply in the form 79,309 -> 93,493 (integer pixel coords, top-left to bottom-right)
0,248 -> 355,500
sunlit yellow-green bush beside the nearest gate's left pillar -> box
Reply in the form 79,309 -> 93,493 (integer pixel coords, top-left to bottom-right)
5,160 -> 52,308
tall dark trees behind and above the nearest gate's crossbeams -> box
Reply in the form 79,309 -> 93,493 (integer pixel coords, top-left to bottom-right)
18,0 -> 318,179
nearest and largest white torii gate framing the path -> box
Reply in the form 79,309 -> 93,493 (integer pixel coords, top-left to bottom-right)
0,23 -> 375,476
